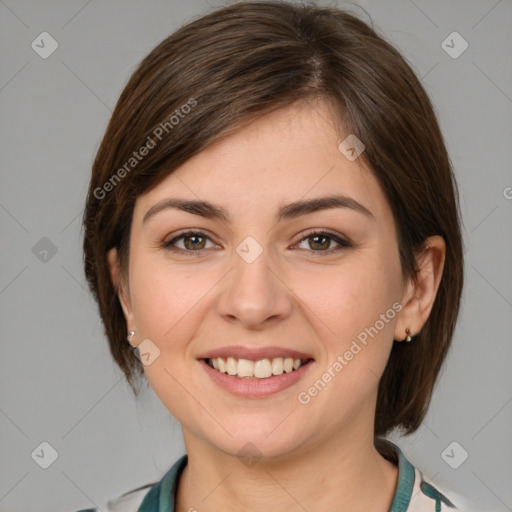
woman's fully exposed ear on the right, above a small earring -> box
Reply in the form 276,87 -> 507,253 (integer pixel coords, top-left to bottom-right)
395,235 -> 446,340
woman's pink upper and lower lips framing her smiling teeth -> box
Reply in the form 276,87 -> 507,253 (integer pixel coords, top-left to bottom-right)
198,347 -> 314,398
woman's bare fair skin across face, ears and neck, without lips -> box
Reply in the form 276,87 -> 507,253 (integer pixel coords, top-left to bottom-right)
108,101 -> 445,512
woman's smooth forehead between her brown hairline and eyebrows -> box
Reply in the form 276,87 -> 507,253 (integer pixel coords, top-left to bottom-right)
134,102 -> 390,225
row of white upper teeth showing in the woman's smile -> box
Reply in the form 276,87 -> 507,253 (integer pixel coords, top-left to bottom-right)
207,357 -> 303,379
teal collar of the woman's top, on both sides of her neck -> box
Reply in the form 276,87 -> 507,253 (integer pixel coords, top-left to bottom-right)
137,440 -> 414,512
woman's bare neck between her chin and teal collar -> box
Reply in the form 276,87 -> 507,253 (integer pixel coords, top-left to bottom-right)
176,426 -> 398,512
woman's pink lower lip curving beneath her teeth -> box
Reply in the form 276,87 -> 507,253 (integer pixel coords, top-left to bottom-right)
199,359 -> 313,398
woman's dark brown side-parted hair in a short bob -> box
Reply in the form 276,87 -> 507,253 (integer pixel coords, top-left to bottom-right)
83,1 -> 464,436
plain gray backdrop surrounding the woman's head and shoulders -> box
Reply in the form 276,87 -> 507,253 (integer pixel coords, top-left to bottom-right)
0,0 -> 512,512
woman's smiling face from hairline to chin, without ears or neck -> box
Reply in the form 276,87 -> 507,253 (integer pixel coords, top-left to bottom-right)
111,103 -> 407,457
